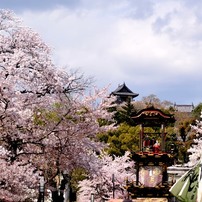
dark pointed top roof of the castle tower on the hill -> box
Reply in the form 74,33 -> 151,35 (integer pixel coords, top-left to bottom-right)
111,83 -> 139,98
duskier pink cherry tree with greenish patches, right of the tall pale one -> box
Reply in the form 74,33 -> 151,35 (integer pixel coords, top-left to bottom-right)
36,87 -> 115,202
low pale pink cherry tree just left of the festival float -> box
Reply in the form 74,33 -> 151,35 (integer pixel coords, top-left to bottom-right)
78,152 -> 135,202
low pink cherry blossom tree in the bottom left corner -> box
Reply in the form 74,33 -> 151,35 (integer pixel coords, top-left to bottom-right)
0,147 -> 38,201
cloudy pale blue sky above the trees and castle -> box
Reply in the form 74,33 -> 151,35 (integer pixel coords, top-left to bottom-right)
0,0 -> 202,106
